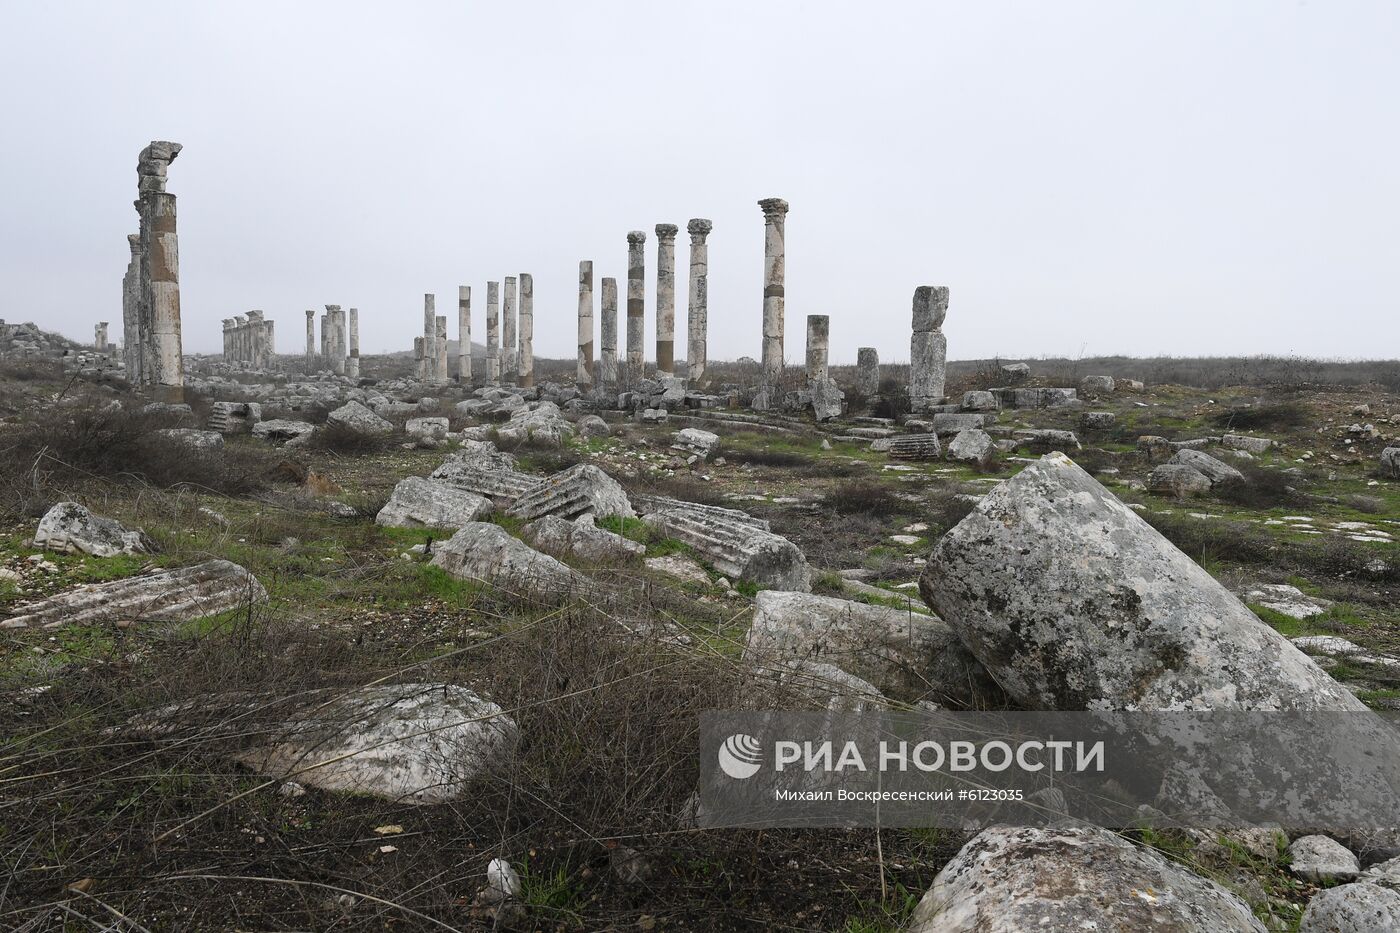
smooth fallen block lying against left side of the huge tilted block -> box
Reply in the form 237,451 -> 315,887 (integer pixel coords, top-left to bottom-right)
743,590 -> 1001,706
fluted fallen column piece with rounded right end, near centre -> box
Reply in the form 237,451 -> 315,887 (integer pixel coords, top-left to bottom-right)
645,509 -> 812,593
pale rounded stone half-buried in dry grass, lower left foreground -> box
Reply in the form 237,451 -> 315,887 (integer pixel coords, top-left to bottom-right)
238,684 -> 518,804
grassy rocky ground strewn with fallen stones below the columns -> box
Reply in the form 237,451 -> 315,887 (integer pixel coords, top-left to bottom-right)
0,353 -> 1400,933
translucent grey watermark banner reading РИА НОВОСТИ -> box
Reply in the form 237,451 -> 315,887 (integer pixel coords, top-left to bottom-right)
699,710 -> 1400,831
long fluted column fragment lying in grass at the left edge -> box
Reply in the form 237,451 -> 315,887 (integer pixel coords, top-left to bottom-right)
0,560 -> 267,629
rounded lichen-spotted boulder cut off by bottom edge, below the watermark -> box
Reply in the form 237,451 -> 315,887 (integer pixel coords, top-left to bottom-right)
909,827 -> 1266,933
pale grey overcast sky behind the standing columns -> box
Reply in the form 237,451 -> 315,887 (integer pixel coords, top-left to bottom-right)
0,0 -> 1400,363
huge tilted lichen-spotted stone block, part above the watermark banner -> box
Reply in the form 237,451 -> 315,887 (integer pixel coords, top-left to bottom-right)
920,454 -> 1365,710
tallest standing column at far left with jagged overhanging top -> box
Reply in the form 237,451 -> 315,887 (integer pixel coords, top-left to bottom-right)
136,140 -> 185,402
